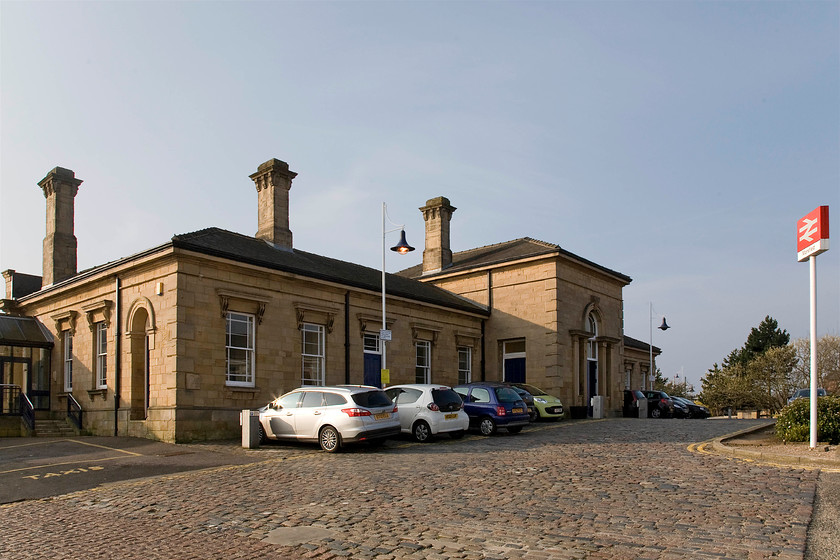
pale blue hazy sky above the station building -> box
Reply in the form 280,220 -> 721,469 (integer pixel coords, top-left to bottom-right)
0,0 -> 840,390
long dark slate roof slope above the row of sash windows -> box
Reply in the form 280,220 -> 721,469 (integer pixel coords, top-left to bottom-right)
172,228 -> 490,316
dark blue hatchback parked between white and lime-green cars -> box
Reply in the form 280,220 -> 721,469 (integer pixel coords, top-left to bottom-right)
453,381 -> 530,436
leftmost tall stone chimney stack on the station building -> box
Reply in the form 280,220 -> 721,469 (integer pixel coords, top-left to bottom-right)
38,167 -> 82,286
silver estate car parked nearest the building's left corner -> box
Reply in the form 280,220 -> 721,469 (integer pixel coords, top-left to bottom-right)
259,385 -> 400,453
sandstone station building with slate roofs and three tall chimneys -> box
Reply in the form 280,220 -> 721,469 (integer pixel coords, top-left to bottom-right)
0,159 -> 659,442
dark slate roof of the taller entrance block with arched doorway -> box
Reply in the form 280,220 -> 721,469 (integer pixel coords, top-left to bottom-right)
398,237 -> 633,284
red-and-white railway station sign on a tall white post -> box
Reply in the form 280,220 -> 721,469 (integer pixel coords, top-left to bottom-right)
796,206 -> 828,449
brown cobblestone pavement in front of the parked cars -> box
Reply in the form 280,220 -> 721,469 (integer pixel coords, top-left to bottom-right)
0,419 -> 820,560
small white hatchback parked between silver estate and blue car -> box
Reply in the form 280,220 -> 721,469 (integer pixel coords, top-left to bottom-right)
385,383 -> 470,442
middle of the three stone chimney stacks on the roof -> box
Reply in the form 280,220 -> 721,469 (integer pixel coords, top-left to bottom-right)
250,159 -> 297,250
